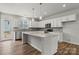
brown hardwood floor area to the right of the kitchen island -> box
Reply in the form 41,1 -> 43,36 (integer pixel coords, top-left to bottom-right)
56,42 -> 79,55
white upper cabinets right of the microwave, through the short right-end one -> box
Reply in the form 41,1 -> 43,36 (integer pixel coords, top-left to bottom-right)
50,14 -> 76,27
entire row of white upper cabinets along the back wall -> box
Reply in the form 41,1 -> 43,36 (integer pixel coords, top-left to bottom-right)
32,14 -> 76,28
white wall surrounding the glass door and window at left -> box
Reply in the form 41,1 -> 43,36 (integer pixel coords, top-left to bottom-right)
0,13 -> 31,40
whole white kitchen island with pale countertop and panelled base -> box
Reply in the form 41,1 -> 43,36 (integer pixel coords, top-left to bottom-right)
22,31 -> 58,55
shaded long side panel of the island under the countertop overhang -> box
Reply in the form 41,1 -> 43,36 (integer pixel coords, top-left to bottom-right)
28,35 -> 43,52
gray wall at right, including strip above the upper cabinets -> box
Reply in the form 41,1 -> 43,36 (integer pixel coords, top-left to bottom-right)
47,9 -> 79,44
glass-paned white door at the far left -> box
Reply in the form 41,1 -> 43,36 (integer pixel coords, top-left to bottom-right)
0,19 -> 12,41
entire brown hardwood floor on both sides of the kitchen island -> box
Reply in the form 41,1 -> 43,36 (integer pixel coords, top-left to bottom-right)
0,40 -> 79,55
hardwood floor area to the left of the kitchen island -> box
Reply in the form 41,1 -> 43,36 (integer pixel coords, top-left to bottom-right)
0,40 -> 41,55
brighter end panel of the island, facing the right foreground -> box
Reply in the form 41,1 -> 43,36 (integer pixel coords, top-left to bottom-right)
42,36 -> 58,55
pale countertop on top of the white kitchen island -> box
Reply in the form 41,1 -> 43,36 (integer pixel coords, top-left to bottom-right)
22,31 -> 58,37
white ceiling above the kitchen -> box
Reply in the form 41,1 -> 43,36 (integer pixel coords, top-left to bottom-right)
0,3 -> 79,17
